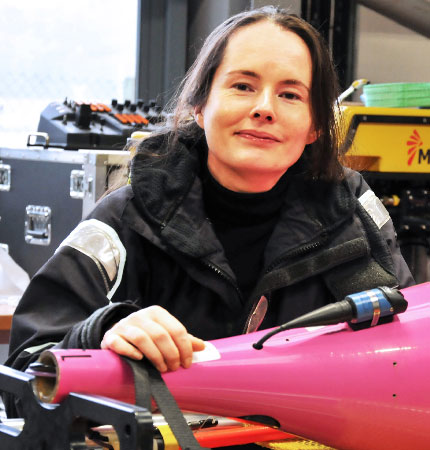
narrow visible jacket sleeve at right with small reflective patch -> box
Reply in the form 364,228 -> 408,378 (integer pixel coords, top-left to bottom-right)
346,170 -> 415,288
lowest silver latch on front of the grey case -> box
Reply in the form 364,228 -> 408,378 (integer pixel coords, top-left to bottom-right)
24,205 -> 51,245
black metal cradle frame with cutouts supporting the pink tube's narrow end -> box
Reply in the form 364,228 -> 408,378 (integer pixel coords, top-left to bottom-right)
0,366 -> 153,450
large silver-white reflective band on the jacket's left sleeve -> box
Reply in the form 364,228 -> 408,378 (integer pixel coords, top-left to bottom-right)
57,219 -> 127,299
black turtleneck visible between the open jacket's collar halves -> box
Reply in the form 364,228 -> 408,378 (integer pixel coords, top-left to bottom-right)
202,164 -> 287,300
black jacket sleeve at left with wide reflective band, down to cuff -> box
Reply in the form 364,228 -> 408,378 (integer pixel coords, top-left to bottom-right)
5,190 -> 139,412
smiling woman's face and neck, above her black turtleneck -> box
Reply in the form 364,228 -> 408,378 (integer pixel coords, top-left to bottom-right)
196,21 -> 316,192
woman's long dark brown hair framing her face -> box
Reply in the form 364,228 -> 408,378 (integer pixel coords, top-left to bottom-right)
142,6 -> 342,180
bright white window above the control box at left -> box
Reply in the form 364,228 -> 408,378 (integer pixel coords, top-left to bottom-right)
0,0 -> 138,147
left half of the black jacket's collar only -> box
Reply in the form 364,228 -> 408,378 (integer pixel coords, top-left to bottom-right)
127,131 -> 226,264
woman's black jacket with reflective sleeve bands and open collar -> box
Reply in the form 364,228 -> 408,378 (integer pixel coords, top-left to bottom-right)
7,132 -> 413,410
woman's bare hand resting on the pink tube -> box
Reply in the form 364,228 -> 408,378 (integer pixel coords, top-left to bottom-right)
100,306 -> 205,372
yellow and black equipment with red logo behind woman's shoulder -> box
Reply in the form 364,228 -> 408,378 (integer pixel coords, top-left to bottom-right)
339,103 -> 430,283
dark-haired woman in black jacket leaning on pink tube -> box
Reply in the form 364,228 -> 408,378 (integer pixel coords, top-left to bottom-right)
4,7 -> 413,414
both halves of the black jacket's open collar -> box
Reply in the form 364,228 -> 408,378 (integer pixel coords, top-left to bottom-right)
127,135 -> 356,273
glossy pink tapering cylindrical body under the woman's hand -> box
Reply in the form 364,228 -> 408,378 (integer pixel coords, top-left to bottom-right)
42,283 -> 430,450
